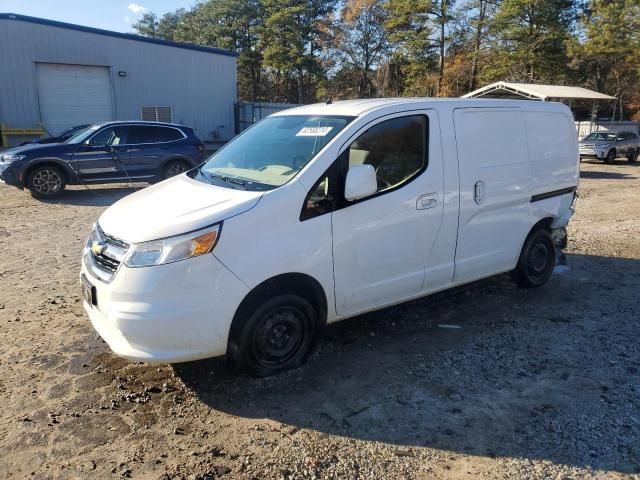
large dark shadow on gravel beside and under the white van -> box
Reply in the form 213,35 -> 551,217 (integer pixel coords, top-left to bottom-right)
174,255 -> 640,473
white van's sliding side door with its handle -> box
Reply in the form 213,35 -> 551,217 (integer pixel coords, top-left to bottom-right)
454,107 -> 533,283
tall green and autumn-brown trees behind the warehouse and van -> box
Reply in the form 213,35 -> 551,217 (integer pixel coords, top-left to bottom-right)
134,0 -> 640,118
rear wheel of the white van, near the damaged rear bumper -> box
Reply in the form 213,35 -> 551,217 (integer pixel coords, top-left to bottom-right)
511,228 -> 556,288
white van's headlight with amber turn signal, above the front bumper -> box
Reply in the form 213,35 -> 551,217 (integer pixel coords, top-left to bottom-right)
124,224 -> 221,267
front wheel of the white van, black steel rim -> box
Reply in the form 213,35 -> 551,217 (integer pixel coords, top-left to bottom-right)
230,294 -> 317,377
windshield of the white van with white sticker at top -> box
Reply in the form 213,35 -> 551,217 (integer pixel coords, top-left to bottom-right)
194,115 -> 352,190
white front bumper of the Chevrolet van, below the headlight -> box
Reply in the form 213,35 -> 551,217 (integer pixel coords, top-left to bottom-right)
81,254 -> 248,363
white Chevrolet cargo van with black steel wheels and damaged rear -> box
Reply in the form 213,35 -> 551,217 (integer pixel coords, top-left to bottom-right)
81,99 -> 579,375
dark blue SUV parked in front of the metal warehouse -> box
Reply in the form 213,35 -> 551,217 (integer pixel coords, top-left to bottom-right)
0,122 -> 206,199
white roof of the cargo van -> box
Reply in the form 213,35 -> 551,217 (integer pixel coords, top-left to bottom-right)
273,97 -> 566,117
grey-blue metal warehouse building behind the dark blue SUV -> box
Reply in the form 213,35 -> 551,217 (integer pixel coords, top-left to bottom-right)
0,13 -> 236,144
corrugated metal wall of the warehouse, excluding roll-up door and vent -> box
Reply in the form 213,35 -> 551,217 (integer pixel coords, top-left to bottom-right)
0,18 -> 236,140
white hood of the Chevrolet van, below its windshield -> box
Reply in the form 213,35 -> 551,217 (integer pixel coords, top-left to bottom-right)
98,174 -> 263,243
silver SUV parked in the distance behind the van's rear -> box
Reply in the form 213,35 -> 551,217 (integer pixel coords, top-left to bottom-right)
579,132 -> 640,163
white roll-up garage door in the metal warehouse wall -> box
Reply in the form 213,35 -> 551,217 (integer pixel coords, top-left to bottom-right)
36,63 -> 113,135
